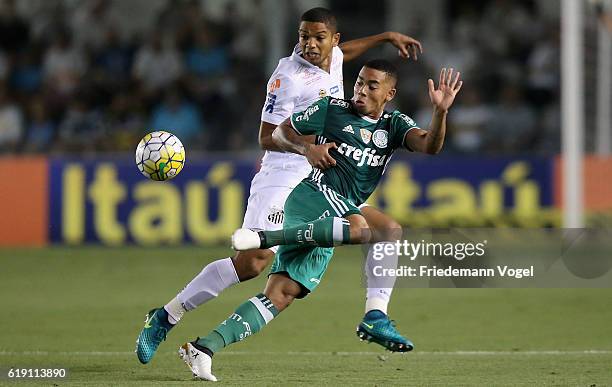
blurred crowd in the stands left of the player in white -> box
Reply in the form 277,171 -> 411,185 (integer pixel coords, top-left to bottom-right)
0,0 -> 266,153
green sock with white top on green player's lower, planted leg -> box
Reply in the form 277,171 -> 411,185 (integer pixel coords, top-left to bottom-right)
196,294 -> 278,353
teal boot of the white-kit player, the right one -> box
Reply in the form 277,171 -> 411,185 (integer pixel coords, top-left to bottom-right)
357,310 -> 414,352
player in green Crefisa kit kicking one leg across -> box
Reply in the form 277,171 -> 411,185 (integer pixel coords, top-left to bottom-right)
179,60 -> 462,380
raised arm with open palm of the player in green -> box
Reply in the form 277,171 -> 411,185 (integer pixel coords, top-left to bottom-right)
404,68 -> 463,154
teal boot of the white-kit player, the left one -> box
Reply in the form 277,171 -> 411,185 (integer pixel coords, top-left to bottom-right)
135,307 -> 174,364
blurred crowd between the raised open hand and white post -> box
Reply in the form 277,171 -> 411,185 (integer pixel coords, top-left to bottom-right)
392,0 -> 561,155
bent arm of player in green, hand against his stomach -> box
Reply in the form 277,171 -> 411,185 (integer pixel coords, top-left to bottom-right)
272,118 -> 337,169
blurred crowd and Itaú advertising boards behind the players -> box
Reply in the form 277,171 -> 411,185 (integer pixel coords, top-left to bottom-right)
0,0 -> 612,245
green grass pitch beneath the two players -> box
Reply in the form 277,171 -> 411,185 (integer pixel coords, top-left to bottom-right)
0,247 -> 612,386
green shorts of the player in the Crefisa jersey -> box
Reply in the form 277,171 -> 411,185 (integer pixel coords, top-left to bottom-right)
270,180 -> 361,298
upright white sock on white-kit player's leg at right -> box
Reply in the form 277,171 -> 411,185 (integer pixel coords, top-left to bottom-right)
365,242 -> 397,314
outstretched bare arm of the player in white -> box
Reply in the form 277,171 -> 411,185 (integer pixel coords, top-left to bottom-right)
340,31 -> 423,62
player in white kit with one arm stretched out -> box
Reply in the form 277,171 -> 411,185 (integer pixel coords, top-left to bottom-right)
136,8 -> 421,364
